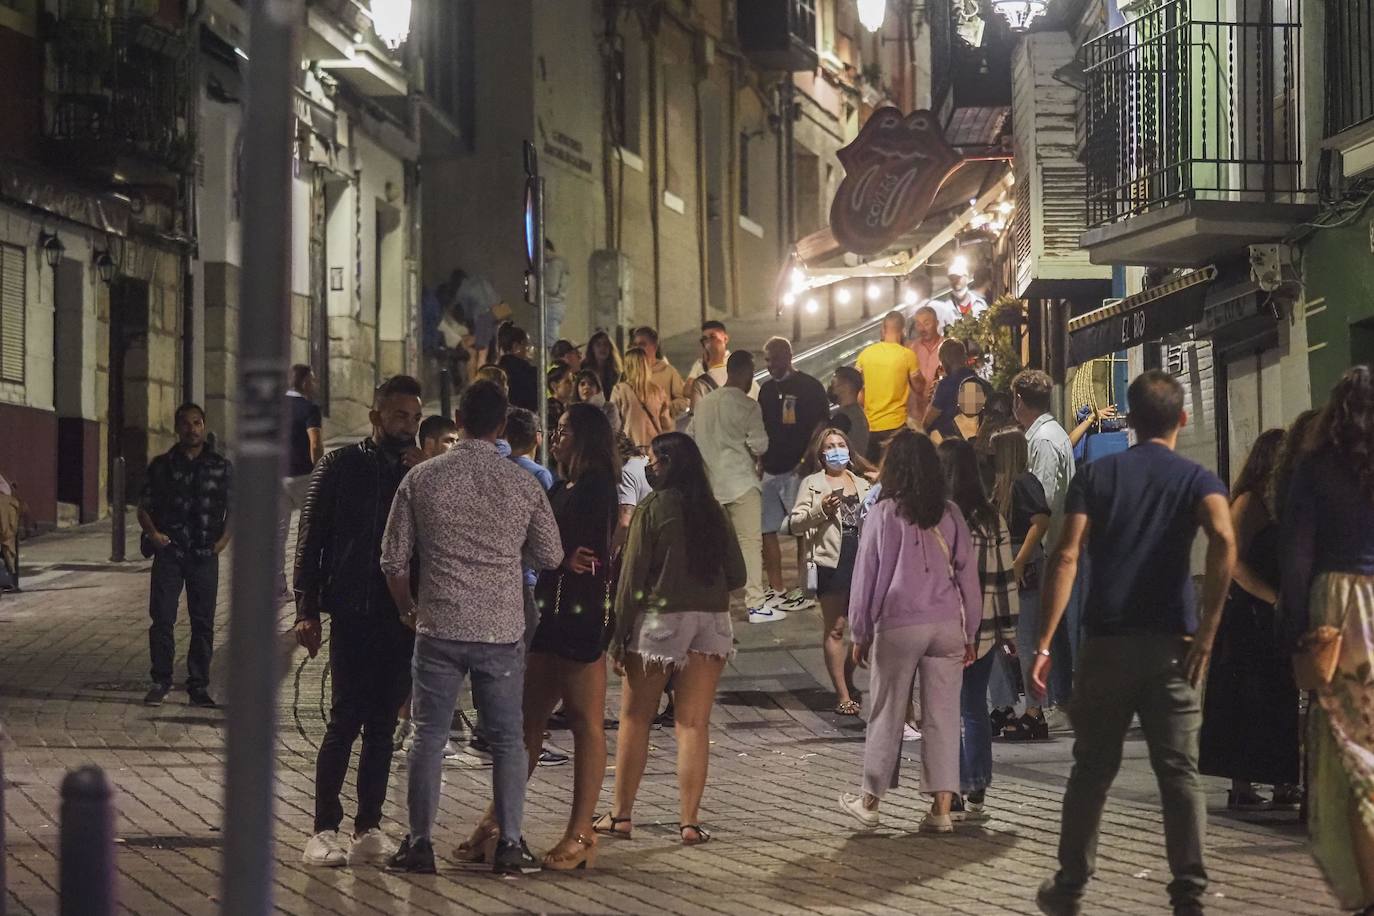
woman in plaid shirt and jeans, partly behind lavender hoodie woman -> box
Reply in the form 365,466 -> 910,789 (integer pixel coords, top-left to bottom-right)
940,439 -> 1017,820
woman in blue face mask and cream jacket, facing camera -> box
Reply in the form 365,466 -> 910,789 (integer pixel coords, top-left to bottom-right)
789,428 -> 871,715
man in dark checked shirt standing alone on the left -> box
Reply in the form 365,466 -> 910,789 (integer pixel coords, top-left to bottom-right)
139,404 -> 234,707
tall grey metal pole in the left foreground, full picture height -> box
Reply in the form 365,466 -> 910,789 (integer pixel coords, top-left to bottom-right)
221,0 -> 305,916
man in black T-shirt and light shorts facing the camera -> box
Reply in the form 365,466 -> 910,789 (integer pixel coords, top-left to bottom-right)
758,336 -> 830,612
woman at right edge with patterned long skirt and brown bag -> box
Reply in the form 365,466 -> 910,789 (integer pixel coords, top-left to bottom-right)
1279,365 -> 1374,912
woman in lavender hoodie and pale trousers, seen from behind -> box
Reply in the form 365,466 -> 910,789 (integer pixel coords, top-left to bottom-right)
840,431 -> 982,834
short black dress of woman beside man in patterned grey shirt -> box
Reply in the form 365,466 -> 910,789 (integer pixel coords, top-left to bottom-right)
529,474 -> 618,663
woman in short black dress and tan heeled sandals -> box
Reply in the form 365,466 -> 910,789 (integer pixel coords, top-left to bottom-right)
458,404 -> 620,871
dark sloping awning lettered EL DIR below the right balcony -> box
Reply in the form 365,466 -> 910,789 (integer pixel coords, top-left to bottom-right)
1069,266 -> 1216,365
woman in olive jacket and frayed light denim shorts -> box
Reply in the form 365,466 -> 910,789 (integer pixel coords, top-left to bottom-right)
596,433 -> 745,846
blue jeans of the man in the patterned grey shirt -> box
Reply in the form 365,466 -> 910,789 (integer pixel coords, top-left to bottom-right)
405,636 -> 528,842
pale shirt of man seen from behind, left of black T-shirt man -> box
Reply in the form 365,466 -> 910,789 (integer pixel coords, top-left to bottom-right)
687,386 -> 768,504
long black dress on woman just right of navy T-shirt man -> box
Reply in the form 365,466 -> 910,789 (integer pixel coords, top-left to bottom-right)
1198,522 -> 1298,786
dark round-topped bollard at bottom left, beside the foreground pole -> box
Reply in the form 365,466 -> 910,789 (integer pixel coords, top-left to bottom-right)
58,766 -> 117,916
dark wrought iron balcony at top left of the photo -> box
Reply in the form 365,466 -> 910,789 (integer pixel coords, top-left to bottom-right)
44,18 -> 195,172
